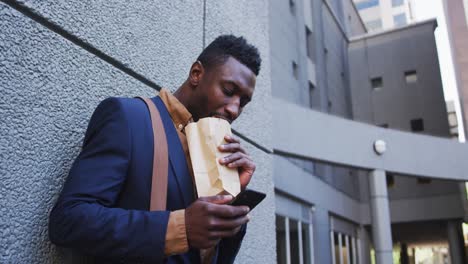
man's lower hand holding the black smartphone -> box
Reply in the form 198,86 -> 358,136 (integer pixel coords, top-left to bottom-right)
185,195 -> 249,249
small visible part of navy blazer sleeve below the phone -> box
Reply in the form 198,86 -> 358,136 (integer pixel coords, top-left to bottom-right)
216,224 -> 247,264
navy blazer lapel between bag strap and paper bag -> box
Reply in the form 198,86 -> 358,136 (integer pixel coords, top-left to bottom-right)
151,97 -> 195,207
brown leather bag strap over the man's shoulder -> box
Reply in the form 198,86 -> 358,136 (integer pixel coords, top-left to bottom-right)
138,97 -> 169,211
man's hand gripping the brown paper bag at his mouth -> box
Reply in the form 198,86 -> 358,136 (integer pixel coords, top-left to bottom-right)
218,136 -> 256,190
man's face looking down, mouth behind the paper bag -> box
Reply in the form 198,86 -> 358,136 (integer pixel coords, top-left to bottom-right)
192,57 -> 256,123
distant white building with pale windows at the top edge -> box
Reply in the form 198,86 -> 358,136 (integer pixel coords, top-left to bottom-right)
354,0 -> 414,31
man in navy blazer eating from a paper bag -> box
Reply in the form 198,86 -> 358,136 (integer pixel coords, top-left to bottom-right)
49,35 -> 261,263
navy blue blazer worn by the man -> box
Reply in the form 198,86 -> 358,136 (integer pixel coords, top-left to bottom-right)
49,97 -> 245,263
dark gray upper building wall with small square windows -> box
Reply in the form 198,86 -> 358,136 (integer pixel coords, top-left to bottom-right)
349,21 -> 449,137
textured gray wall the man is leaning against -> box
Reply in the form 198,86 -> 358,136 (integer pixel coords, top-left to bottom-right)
0,0 -> 276,263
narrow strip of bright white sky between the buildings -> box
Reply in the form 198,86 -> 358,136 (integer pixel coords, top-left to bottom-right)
412,0 -> 465,142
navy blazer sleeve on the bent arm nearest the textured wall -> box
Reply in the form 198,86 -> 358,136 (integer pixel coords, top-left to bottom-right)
49,98 -> 169,263
